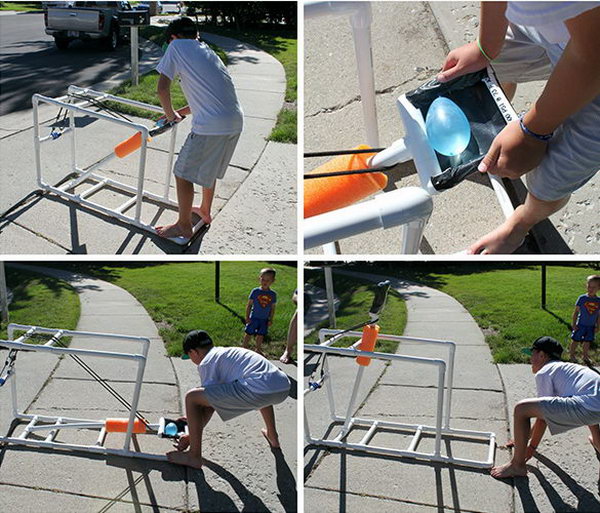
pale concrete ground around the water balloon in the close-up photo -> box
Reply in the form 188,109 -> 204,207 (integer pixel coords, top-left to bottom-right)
304,1 -> 600,255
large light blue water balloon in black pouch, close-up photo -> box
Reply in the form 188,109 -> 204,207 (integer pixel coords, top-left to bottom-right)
425,96 -> 471,157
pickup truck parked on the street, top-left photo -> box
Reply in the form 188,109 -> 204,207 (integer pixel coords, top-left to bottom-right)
44,2 -> 131,50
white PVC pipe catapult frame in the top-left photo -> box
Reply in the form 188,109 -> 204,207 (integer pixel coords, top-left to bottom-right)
32,85 -> 201,244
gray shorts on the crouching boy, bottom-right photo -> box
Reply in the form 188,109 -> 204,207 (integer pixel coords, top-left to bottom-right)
540,397 -> 600,435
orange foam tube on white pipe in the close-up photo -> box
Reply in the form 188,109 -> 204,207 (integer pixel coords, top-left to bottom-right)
304,145 -> 387,218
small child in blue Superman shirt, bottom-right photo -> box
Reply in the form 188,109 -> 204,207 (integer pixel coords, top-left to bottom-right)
569,274 -> 600,363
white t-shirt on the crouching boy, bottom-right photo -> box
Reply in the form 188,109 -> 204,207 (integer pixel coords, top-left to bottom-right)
535,361 -> 600,411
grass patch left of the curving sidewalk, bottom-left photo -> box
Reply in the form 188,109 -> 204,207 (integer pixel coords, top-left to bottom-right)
0,265 -> 80,343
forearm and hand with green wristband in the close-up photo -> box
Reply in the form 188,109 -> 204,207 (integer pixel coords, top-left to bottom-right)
437,2 -> 508,82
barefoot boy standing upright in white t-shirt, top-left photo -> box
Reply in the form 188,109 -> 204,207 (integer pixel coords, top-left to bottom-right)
156,18 -> 244,238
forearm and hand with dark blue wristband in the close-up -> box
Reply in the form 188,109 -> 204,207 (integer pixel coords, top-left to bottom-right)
479,7 -> 600,179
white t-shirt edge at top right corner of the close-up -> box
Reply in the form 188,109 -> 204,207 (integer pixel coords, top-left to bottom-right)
506,2 -> 600,44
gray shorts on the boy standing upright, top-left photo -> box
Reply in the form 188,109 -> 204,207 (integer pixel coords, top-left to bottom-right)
173,133 -> 240,189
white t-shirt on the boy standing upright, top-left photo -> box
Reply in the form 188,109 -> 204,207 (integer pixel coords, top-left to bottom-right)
156,39 -> 244,135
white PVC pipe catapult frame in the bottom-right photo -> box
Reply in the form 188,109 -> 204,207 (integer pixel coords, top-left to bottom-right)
304,329 -> 496,468
